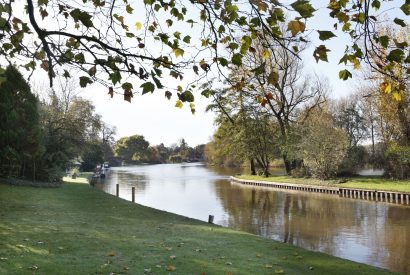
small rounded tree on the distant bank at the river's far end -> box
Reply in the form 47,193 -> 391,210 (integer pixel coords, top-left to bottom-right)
113,135 -> 149,162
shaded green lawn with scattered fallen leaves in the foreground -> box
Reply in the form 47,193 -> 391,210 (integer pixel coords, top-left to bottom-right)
0,178 -> 389,275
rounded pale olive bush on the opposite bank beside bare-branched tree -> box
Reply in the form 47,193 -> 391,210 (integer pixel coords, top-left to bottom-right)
300,110 -> 348,180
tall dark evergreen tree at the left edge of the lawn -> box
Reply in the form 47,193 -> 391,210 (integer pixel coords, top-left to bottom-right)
0,65 -> 43,180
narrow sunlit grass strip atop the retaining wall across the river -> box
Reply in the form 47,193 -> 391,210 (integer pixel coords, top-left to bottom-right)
235,175 -> 410,193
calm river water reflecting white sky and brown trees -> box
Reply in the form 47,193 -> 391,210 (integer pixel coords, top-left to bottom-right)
97,163 -> 410,274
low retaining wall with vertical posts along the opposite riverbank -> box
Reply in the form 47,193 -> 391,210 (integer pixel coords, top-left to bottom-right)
230,177 -> 410,205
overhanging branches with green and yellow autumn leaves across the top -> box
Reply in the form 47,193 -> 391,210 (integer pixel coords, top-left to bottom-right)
0,0 -> 410,104
